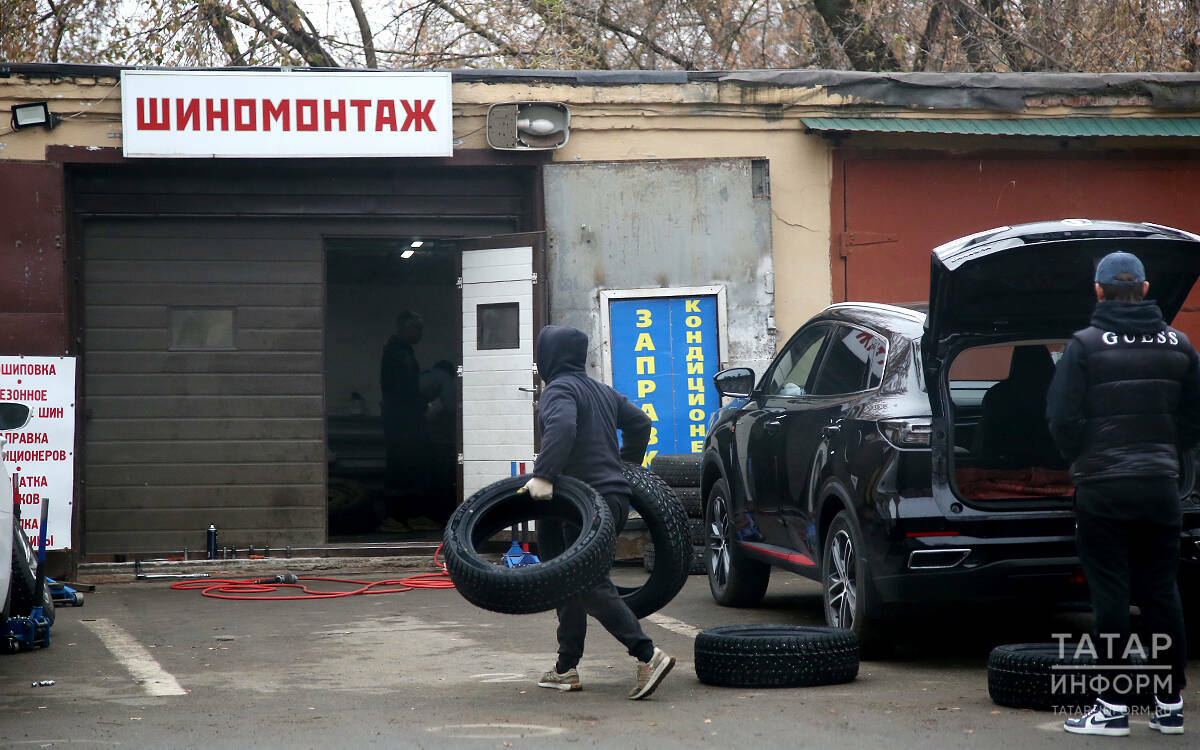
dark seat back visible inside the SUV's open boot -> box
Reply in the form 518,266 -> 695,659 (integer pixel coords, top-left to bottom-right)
974,344 -> 1062,466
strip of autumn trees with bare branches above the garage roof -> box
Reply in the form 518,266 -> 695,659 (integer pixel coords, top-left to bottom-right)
7,0 -> 1200,72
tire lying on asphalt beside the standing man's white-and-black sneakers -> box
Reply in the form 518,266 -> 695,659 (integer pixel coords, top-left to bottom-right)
988,642 -> 1096,710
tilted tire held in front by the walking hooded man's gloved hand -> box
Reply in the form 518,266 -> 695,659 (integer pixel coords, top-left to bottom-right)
443,476 -> 616,614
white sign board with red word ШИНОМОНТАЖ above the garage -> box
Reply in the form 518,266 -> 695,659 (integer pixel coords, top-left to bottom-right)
121,71 -> 454,157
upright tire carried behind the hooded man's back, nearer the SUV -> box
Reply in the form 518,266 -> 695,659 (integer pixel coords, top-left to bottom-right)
617,463 -> 694,619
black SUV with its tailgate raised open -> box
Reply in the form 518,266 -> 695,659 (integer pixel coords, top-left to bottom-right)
702,220 -> 1200,648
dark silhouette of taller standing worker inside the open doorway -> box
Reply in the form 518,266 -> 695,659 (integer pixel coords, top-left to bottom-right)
379,310 -> 425,521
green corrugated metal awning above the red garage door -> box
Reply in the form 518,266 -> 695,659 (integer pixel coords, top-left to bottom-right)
803,118 -> 1200,138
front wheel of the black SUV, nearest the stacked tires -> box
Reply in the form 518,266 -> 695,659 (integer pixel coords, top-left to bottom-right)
704,479 -> 770,607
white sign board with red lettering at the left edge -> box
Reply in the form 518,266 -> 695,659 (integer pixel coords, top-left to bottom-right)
0,356 -> 76,550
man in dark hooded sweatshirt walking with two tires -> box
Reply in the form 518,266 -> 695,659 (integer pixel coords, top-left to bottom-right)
524,325 -> 676,701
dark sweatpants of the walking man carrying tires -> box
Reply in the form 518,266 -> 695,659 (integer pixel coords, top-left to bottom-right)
538,494 -> 654,674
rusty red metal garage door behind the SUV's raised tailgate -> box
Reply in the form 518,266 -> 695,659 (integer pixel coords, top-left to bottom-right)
833,154 -> 1200,338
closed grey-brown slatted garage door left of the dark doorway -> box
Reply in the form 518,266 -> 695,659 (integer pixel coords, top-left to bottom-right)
84,220 -> 325,553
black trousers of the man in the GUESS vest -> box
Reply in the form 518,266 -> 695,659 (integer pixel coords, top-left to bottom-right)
1075,485 -> 1188,703
